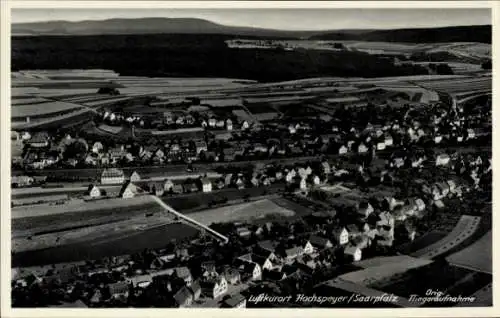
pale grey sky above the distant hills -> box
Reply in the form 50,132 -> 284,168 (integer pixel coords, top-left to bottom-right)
11,8 -> 492,30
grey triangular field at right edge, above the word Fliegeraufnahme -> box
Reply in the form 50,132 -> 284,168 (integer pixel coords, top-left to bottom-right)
446,231 -> 493,274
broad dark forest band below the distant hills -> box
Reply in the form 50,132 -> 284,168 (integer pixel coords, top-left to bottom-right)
11,34 -> 428,82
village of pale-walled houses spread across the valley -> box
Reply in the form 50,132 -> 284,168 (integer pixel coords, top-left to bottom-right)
11,79 -> 491,308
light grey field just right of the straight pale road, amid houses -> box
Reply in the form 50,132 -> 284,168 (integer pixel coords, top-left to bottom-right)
189,199 -> 295,225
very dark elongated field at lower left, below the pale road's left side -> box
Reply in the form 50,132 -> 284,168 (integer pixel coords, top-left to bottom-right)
12,223 -> 198,267
